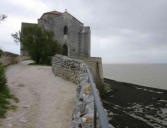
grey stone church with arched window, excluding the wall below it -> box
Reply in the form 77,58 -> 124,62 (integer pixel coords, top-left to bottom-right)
21,11 -> 90,58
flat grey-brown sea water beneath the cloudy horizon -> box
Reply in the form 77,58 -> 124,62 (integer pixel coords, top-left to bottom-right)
103,64 -> 167,90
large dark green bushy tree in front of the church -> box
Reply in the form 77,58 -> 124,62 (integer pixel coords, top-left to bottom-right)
12,26 -> 62,65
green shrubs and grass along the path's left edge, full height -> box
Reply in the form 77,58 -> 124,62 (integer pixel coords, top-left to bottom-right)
0,64 -> 18,118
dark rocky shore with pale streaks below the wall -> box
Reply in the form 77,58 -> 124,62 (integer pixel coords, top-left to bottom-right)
103,79 -> 167,128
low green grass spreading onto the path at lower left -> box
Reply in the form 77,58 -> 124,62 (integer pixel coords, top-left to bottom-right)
0,85 -> 19,118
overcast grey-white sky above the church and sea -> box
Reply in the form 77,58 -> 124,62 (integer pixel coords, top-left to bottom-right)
0,0 -> 167,63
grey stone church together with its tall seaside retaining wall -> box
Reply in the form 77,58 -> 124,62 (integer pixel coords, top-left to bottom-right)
20,10 -> 103,90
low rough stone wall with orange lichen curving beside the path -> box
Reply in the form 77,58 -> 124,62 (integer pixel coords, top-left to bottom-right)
52,55 -> 100,128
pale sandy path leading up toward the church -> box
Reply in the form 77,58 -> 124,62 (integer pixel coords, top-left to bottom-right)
0,61 -> 76,128
